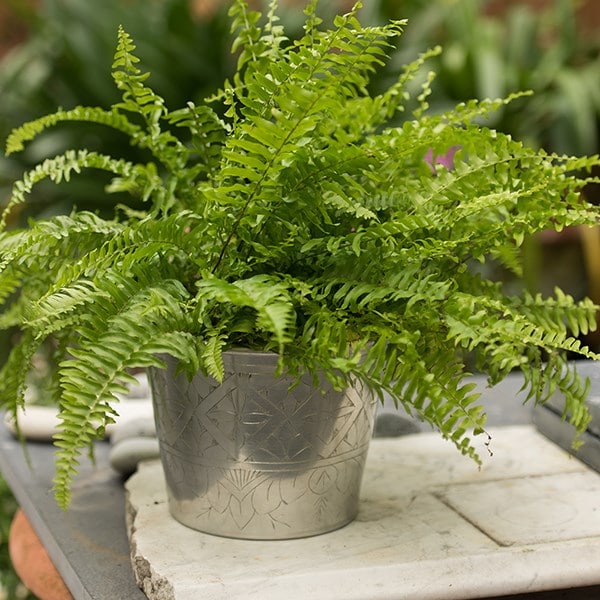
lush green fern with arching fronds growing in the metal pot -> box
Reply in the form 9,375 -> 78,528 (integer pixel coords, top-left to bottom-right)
0,0 -> 600,506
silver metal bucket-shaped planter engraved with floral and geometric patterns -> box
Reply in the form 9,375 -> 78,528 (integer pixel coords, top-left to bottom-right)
149,351 -> 375,539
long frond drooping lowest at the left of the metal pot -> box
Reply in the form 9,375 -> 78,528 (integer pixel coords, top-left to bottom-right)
54,278 -> 195,507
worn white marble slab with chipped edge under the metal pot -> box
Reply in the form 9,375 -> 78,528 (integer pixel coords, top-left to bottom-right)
126,427 -> 600,600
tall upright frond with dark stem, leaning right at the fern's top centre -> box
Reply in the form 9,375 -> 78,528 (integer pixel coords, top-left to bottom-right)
213,2 -> 408,273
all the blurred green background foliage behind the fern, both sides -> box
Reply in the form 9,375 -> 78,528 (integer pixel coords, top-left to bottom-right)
0,0 -> 600,599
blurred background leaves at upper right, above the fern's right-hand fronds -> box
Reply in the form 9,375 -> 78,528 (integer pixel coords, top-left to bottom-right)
384,0 -> 600,154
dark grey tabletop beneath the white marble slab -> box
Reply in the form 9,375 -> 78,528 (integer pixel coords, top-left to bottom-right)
0,370 -> 600,600
